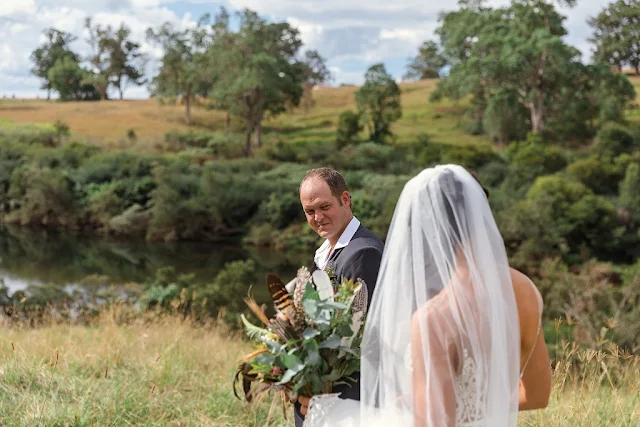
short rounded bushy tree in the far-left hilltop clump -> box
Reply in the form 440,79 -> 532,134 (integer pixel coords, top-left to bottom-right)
47,56 -> 100,101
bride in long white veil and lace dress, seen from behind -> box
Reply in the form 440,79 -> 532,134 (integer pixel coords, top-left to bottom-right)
305,165 -> 551,427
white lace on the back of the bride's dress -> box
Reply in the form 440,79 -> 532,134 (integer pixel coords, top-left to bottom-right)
453,348 -> 486,427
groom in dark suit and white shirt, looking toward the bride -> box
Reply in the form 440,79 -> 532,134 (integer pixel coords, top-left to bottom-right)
294,168 -> 384,427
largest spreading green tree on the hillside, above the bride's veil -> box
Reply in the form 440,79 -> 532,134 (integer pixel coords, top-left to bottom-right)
432,0 -> 632,137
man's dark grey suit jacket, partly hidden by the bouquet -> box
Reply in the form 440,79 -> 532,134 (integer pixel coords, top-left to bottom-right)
294,224 -> 384,427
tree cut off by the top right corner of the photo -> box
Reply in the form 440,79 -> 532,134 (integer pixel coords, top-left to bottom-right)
588,0 -> 640,74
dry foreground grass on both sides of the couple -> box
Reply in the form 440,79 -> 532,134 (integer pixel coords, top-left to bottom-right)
0,311 -> 640,427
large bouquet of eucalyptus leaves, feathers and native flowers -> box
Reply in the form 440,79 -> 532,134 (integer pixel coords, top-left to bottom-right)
233,267 -> 367,416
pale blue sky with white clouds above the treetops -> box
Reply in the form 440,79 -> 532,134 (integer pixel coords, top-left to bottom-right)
0,0 -> 607,98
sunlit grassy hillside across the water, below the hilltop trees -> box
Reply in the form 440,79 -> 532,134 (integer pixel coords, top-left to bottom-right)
0,77 -> 640,150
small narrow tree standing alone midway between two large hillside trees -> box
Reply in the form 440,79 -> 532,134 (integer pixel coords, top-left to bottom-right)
355,64 -> 402,142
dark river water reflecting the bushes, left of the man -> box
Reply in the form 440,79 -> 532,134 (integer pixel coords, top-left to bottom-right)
0,227 -> 313,296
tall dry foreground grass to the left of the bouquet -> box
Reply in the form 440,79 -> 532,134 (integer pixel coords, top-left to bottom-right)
0,309 -> 283,426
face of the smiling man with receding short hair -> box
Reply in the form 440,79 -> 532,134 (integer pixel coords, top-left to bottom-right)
300,178 -> 351,239
